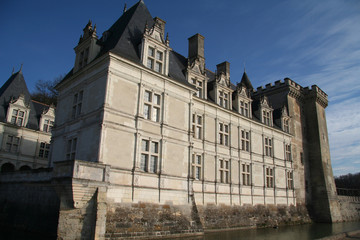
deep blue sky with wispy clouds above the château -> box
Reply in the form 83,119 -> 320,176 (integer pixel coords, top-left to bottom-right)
0,0 -> 360,175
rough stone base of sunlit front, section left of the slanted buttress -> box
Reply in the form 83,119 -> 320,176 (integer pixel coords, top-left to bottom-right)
106,203 -> 202,239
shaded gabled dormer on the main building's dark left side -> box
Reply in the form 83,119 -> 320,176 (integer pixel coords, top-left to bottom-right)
74,20 -> 100,72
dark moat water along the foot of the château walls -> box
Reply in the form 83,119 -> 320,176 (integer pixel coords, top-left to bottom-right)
0,222 -> 360,240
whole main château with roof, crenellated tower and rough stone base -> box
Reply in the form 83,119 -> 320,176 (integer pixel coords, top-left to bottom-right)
0,1 -> 342,239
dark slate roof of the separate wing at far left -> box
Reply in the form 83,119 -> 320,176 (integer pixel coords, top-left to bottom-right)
0,70 -> 49,130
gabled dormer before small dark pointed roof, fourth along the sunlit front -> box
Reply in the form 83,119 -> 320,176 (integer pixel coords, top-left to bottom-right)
233,71 -> 253,118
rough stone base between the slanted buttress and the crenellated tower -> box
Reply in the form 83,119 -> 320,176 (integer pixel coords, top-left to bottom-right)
198,205 -> 311,230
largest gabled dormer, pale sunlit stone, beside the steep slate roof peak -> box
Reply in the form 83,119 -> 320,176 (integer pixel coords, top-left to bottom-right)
141,17 -> 171,75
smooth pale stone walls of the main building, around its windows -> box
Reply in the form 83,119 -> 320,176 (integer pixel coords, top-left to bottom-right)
53,55 -> 295,205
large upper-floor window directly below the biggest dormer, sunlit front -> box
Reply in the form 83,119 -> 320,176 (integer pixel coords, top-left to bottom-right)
143,90 -> 161,122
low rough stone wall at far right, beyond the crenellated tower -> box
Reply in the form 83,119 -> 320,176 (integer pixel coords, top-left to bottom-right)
338,196 -> 360,222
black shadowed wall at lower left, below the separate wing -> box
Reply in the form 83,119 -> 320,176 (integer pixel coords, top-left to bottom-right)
0,170 -> 59,239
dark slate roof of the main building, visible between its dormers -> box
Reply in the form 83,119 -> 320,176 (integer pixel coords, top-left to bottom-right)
63,0 -> 286,131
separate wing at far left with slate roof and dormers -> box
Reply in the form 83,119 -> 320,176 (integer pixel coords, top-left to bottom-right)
0,70 -> 55,172
